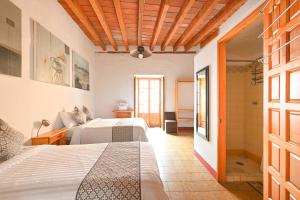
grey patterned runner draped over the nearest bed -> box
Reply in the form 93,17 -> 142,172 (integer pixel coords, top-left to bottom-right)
76,142 -> 141,200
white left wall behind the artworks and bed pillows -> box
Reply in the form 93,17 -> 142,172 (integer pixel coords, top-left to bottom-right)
0,0 -> 95,144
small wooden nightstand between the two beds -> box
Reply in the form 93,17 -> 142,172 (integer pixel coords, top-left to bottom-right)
31,128 -> 68,145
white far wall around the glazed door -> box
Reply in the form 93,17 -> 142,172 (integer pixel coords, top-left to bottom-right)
95,54 -> 194,117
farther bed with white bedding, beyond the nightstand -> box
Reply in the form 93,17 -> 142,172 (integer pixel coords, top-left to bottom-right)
67,118 -> 148,144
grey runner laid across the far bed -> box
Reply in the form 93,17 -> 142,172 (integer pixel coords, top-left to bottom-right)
112,118 -> 134,142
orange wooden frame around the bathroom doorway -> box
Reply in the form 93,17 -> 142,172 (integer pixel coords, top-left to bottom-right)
217,3 -> 265,182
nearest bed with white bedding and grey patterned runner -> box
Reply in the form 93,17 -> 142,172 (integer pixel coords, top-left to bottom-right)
0,142 -> 168,200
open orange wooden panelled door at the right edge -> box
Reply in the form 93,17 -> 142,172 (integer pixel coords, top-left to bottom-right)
264,0 -> 300,200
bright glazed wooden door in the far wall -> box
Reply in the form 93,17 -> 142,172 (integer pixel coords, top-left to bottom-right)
136,78 -> 162,127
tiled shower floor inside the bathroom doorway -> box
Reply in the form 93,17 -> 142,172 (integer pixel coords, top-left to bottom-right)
226,156 -> 263,182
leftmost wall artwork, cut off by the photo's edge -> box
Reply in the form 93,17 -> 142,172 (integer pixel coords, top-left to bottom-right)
0,0 -> 22,77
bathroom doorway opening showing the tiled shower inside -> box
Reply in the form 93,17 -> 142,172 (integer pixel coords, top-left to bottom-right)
226,17 -> 264,184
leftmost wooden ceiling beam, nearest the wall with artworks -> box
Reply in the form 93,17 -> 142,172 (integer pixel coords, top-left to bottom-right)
58,0 -> 106,51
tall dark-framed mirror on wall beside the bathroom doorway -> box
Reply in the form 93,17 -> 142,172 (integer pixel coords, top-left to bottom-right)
196,66 -> 209,141
